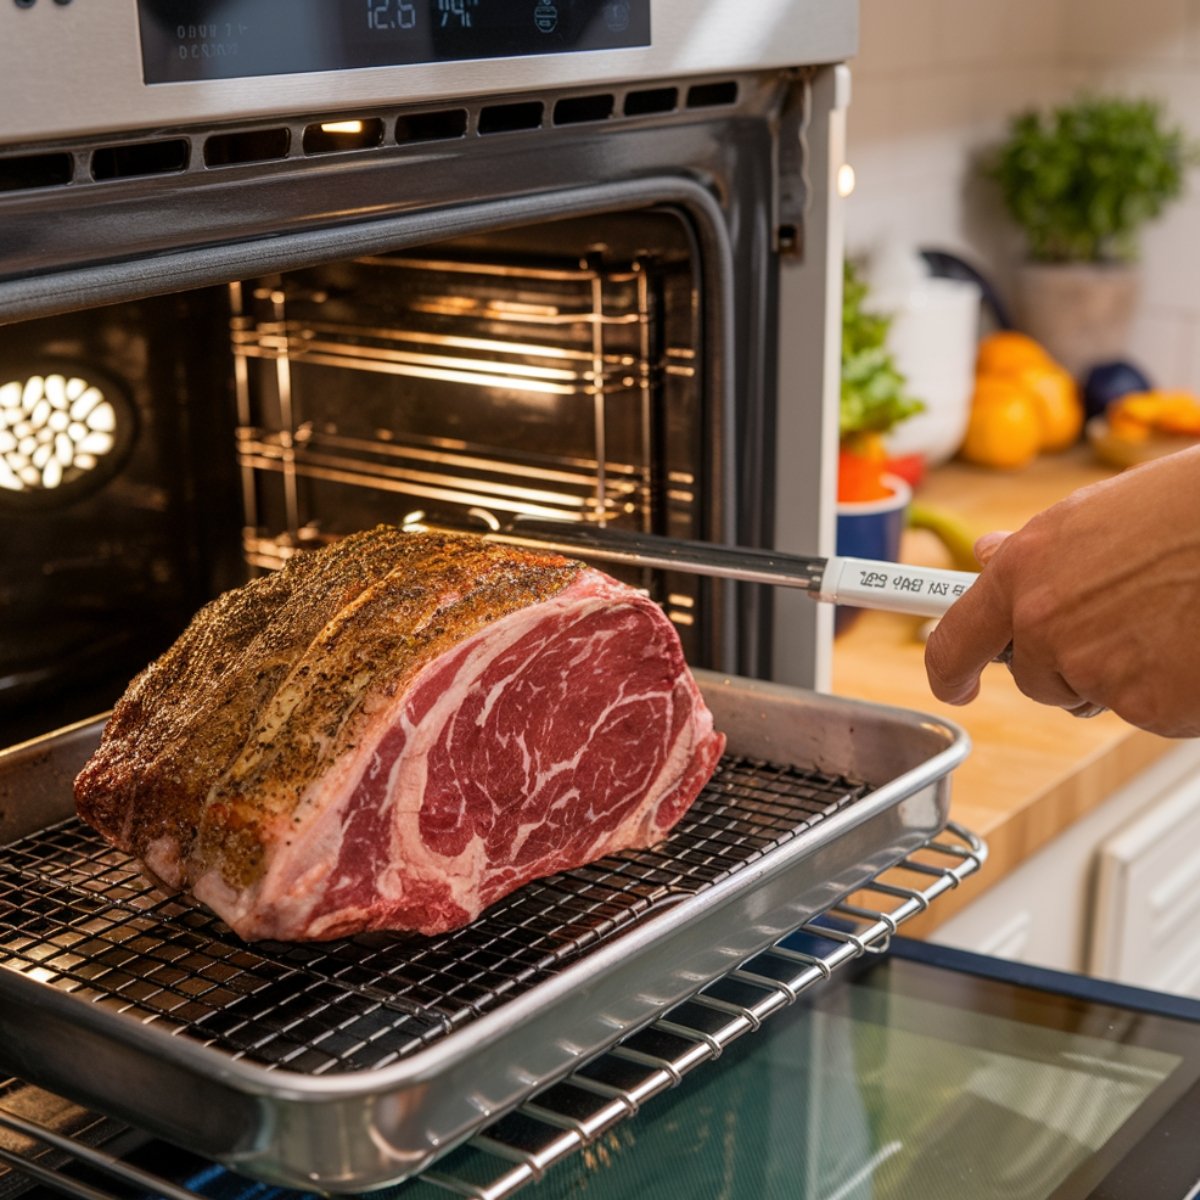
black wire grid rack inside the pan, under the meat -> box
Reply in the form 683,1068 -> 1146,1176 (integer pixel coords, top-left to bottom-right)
0,756 -> 868,1075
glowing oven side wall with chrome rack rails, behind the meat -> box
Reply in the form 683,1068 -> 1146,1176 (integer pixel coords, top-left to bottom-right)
229,214 -> 703,652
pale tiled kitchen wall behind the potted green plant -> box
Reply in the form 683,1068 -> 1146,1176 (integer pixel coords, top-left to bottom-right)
847,0 -> 1200,390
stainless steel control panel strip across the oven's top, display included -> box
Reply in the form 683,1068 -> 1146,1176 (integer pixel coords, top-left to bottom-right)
0,0 -> 858,144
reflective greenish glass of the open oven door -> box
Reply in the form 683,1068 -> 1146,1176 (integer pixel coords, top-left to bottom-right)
403,948 -> 1200,1200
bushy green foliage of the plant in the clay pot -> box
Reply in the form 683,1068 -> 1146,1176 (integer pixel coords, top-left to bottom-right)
988,96 -> 1200,263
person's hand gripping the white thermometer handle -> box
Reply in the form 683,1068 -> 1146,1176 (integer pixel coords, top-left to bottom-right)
925,448 -> 1200,737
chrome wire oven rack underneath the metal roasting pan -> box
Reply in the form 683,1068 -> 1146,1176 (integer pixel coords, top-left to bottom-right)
0,822 -> 988,1200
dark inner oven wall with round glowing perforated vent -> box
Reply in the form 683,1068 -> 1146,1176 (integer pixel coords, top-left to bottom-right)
0,289 -> 241,745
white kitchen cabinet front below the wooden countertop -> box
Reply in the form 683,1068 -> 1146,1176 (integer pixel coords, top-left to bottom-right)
931,742 -> 1200,991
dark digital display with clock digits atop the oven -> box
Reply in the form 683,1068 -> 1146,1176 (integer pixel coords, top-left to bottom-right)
138,0 -> 650,84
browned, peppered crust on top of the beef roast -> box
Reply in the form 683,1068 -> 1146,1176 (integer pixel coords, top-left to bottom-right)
76,526 -> 582,888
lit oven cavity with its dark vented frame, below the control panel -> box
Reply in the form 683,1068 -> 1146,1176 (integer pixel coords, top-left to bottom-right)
0,70 -> 806,742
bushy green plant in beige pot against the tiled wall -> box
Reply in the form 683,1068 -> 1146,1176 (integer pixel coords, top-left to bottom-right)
988,96 -> 1196,376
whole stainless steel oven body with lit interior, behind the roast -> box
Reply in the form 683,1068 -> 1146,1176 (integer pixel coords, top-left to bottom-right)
0,0 -> 856,744
